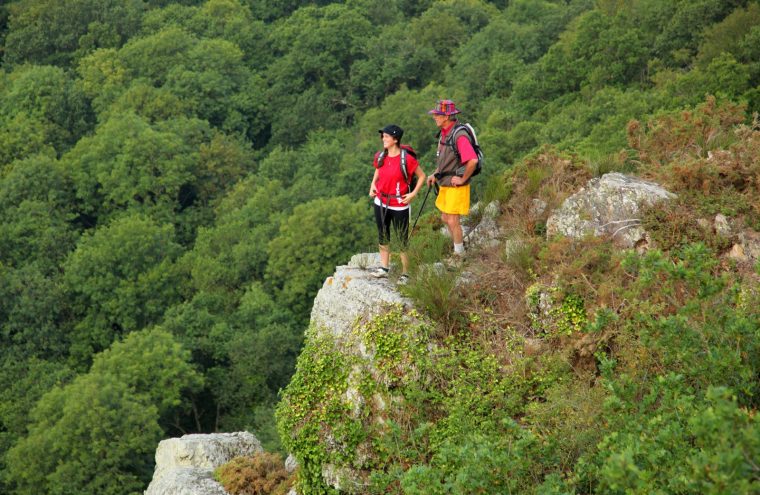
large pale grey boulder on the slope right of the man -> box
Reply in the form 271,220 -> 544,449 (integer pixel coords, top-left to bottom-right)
546,173 -> 676,248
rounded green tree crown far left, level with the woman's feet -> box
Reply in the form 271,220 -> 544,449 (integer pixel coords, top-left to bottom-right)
63,214 -> 180,363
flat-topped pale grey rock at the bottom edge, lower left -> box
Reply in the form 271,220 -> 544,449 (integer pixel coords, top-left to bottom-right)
145,431 -> 263,495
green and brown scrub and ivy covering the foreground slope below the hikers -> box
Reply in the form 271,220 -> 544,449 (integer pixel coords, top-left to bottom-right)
276,99 -> 760,495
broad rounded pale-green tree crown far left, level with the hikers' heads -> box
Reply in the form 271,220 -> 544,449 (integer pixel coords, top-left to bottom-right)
63,113 -> 251,237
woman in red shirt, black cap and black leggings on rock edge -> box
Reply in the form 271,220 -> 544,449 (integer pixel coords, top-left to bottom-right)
369,124 -> 425,283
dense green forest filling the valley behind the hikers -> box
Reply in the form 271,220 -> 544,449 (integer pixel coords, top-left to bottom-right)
0,0 -> 760,495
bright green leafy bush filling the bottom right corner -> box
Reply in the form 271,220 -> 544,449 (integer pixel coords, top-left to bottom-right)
580,374 -> 760,494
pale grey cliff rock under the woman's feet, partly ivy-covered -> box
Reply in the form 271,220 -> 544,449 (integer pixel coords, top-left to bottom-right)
305,262 -> 435,494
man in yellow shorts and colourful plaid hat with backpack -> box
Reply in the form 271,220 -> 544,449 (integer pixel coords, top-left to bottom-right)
427,100 -> 478,257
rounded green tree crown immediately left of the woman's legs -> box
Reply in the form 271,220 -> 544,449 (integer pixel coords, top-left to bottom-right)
266,196 -> 372,323
